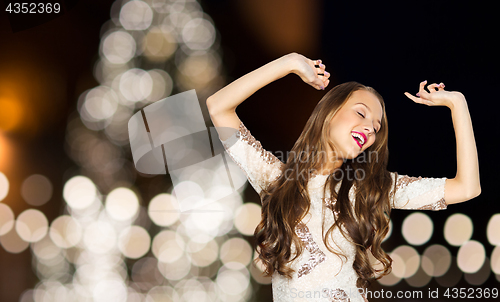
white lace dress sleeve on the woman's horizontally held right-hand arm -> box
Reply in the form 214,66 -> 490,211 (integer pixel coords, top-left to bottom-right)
391,172 -> 448,211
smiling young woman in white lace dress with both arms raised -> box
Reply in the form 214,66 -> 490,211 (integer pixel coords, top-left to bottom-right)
207,53 -> 481,301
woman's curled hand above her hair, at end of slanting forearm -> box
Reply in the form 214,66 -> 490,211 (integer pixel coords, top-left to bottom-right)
290,53 -> 330,90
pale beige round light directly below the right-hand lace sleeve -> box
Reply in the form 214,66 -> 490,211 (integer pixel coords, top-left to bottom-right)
402,212 -> 434,245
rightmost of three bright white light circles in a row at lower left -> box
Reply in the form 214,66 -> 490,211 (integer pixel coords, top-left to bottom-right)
148,193 -> 180,226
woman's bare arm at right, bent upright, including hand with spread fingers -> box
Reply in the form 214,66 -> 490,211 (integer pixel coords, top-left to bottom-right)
405,81 -> 481,204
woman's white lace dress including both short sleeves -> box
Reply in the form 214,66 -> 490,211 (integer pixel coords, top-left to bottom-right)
221,123 -> 447,302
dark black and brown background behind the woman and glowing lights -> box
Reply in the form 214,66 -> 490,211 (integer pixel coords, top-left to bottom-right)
0,0 -> 500,301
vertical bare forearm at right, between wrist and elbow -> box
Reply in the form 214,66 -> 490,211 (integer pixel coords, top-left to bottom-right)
450,98 -> 481,196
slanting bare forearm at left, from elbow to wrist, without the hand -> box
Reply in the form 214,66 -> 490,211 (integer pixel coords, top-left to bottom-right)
207,54 -> 292,112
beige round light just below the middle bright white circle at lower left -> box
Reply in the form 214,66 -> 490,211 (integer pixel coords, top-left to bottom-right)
118,225 -> 151,259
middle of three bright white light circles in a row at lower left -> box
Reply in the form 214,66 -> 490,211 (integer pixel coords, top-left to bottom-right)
106,188 -> 139,221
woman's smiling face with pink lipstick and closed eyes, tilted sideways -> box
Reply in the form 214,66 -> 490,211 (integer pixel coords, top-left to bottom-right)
326,90 -> 383,160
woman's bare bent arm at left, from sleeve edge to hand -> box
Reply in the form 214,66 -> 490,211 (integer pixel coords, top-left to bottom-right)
207,53 -> 330,140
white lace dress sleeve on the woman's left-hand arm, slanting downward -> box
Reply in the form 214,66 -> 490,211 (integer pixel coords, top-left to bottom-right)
219,122 -> 284,194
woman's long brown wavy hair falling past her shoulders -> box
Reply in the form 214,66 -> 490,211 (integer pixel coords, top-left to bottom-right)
254,82 -> 392,289
